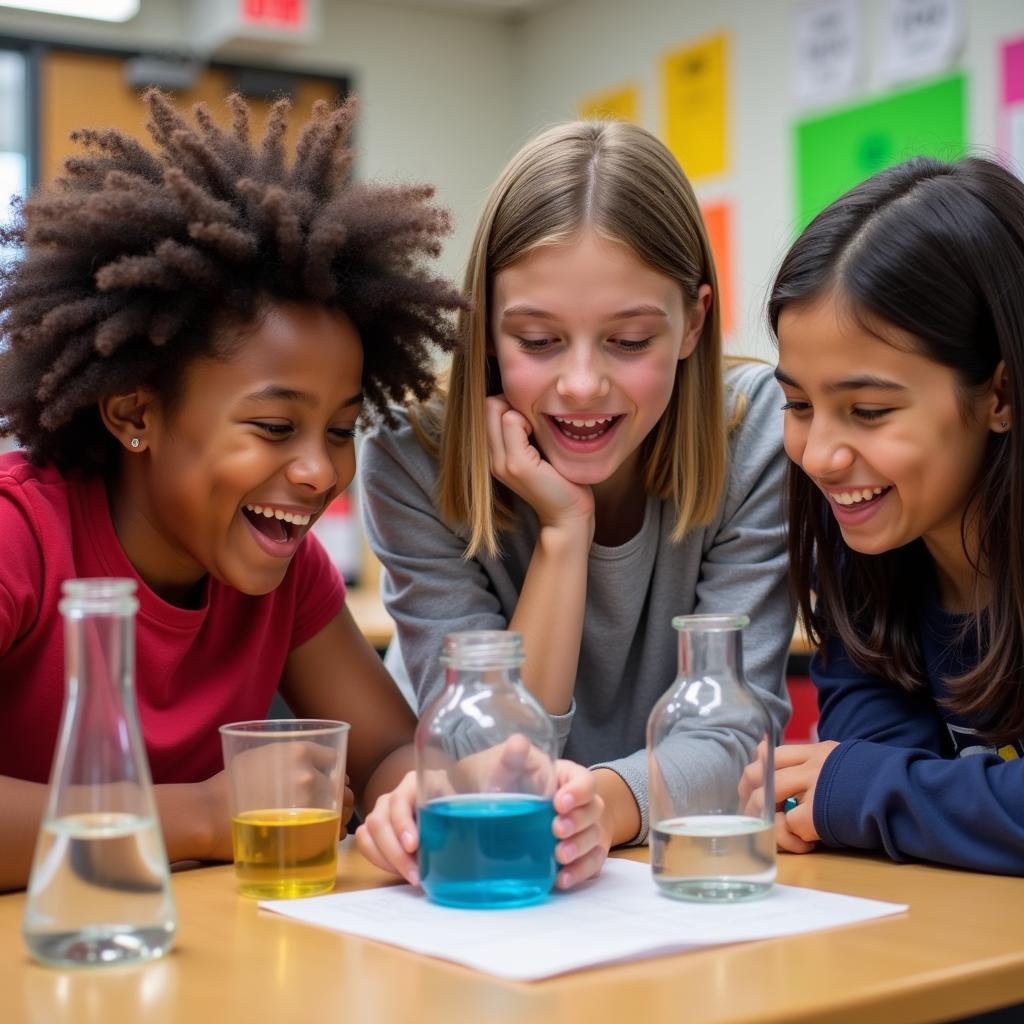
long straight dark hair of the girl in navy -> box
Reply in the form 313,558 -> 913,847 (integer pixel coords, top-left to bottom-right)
768,158 -> 1024,741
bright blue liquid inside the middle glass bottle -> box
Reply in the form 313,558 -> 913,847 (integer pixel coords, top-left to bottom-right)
419,794 -> 558,909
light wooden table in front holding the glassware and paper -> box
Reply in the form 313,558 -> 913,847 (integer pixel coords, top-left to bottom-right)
0,844 -> 1024,1024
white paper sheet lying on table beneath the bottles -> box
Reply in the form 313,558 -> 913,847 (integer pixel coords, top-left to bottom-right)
259,859 -> 906,981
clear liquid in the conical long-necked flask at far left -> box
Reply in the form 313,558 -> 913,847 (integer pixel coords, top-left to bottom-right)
25,813 -> 174,965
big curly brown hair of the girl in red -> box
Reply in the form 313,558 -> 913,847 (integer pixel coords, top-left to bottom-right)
0,89 -> 464,472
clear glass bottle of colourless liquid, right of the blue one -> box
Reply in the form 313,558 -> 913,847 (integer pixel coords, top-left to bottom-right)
647,615 -> 775,902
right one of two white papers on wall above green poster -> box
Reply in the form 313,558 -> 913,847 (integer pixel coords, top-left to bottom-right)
882,0 -> 966,82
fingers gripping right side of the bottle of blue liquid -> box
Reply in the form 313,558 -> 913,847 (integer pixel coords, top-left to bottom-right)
553,760 -> 611,889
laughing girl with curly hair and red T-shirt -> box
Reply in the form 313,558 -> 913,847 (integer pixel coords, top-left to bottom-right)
0,91 -> 598,889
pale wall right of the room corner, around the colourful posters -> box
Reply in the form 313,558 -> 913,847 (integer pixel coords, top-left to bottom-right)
516,0 -> 1024,357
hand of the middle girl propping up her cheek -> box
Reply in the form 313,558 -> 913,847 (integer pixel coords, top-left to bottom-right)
486,395 -> 594,536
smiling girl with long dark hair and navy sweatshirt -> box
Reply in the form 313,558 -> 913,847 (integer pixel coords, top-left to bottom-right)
769,159 -> 1024,874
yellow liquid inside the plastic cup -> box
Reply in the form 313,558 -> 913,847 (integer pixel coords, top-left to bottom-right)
231,807 -> 341,899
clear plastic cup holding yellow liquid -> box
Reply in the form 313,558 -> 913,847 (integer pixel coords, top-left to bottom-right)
220,719 -> 349,899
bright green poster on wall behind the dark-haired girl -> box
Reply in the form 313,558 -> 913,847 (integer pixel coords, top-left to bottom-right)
795,75 -> 967,228
